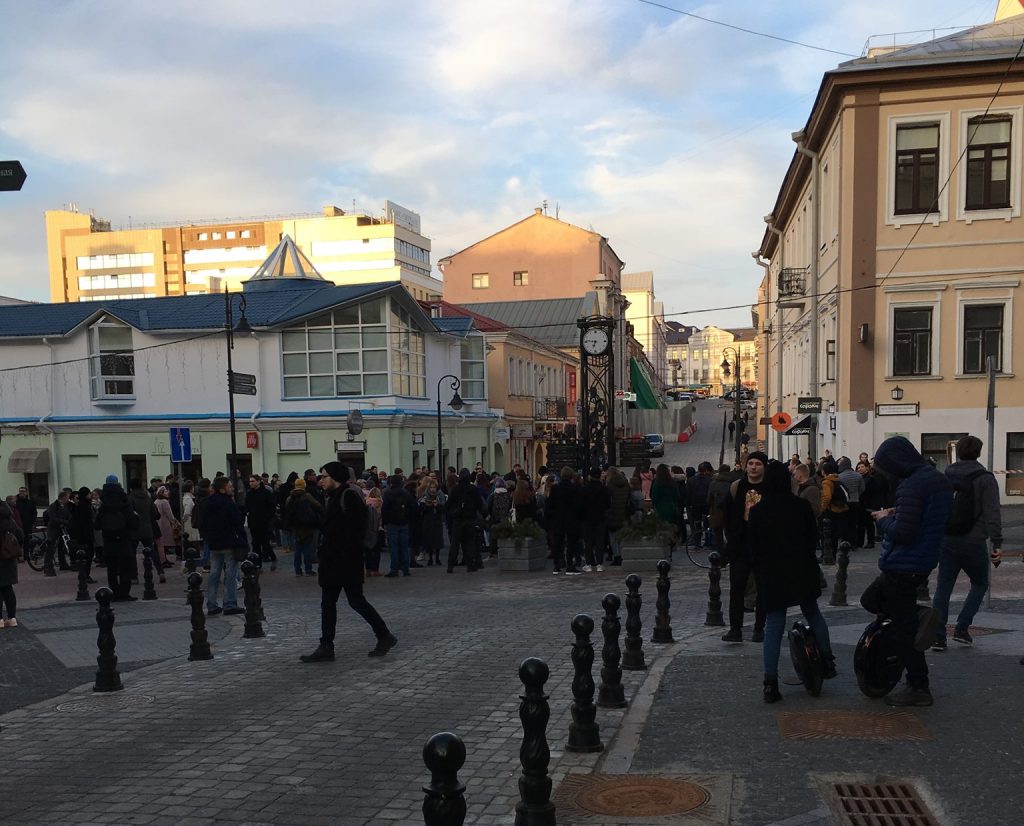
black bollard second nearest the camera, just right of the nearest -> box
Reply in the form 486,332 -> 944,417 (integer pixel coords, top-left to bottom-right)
515,657 -> 555,826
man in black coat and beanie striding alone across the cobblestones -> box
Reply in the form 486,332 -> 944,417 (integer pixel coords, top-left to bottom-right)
299,462 -> 398,662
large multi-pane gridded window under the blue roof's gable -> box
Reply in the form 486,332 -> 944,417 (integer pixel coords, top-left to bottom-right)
281,298 -> 405,398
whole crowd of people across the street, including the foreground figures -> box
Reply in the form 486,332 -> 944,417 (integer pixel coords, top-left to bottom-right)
0,429 -> 1002,705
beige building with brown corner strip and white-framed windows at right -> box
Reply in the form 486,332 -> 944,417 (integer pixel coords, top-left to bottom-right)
755,14 -> 1024,493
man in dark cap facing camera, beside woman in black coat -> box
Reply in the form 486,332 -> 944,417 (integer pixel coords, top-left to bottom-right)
722,450 -> 768,643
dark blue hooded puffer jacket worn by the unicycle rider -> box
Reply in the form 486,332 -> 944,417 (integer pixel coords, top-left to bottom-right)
874,436 -> 953,573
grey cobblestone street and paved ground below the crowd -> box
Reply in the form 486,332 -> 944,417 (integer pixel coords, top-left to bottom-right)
0,528 -> 1024,826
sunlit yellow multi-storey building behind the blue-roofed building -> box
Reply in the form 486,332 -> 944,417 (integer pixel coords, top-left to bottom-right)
46,202 -> 441,302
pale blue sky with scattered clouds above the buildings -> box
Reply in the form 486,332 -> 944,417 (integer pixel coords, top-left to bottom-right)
0,0 -> 996,327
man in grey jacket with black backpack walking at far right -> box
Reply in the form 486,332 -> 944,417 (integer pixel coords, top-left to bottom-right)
932,436 -> 1002,651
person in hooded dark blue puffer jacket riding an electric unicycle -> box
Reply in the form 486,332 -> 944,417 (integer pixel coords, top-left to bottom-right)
860,436 -> 953,706
